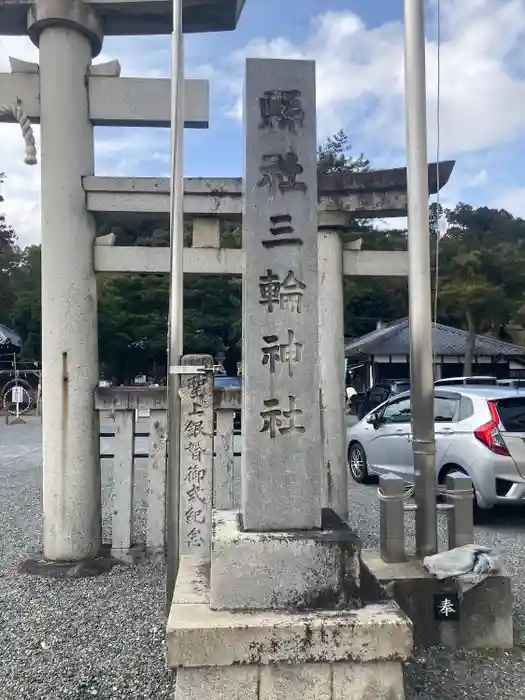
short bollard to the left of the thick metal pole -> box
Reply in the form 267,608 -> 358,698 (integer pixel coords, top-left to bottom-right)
377,474 -> 405,563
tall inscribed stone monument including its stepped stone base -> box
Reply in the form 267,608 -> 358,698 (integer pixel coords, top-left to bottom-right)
167,59 -> 412,700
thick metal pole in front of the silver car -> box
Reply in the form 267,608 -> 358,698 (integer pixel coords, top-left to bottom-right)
405,0 -> 437,557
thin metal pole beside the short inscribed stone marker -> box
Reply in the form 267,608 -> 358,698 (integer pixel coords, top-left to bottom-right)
166,0 -> 184,614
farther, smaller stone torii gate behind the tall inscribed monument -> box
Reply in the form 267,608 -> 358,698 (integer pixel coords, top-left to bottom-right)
84,161 -> 454,520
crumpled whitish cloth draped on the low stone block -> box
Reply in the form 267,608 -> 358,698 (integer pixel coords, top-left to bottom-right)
423,544 -> 501,598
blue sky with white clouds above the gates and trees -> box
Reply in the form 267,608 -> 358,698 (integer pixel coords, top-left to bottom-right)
0,0 -> 525,244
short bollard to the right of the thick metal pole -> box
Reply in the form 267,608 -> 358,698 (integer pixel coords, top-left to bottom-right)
446,472 -> 474,549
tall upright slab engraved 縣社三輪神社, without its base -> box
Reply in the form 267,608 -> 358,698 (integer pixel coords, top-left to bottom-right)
242,59 -> 322,531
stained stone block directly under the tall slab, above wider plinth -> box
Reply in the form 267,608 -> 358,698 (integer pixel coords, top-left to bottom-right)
210,510 -> 360,610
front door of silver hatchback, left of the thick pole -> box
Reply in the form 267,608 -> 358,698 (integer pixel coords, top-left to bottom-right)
367,396 -> 413,478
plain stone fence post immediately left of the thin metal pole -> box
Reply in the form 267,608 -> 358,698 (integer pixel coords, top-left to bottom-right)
146,409 -> 168,559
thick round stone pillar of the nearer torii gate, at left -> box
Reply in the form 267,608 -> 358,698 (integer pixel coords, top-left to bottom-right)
29,0 -> 102,561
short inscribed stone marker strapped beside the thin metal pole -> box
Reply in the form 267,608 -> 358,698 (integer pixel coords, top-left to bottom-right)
180,355 -> 213,559
